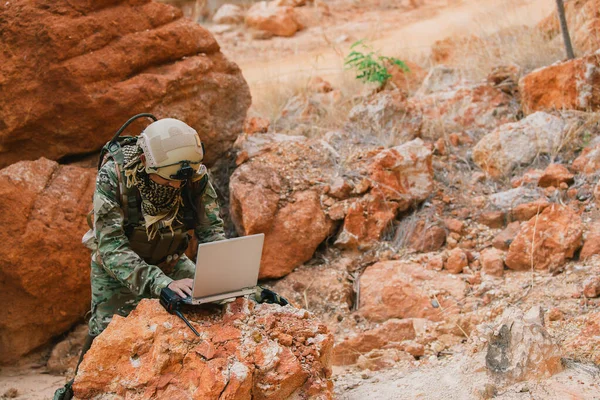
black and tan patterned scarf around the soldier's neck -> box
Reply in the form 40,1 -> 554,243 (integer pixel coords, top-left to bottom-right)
123,145 -> 183,240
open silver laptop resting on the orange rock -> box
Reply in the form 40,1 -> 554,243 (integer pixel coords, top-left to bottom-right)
184,233 -> 265,305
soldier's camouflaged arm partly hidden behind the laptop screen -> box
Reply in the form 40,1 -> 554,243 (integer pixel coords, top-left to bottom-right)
196,181 -> 226,243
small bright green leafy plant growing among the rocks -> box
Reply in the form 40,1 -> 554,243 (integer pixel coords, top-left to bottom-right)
344,40 -> 409,86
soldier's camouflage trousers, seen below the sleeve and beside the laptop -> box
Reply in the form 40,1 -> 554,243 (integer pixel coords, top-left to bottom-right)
89,255 -> 196,336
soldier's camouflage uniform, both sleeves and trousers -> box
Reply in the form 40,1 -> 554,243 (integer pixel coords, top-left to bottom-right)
84,160 -> 225,336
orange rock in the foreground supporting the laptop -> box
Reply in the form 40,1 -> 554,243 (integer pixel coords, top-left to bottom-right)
73,298 -> 333,399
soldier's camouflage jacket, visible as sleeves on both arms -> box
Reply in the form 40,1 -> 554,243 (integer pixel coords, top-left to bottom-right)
83,160 -> 225,297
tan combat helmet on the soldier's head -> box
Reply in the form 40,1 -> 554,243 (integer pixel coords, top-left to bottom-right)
138,118 -> 206,181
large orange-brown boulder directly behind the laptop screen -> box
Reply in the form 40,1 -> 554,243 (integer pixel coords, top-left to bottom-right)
230,176 -> 333,279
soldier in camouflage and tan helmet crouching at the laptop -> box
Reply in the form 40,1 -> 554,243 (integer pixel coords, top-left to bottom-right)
54,118 -> 225,399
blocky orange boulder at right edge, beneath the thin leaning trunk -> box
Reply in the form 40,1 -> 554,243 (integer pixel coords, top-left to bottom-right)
519,52 -> 600,114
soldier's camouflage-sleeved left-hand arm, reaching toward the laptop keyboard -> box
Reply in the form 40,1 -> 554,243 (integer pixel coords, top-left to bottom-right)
94,161 -> 173,297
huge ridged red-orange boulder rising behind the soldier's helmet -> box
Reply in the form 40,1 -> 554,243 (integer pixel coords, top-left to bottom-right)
0,0 -> 251,168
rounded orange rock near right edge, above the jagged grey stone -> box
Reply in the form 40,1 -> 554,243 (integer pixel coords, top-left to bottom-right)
505,204 -> 583,272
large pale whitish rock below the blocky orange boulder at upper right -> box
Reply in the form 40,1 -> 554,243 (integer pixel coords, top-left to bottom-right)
473,112 -> 567,178
